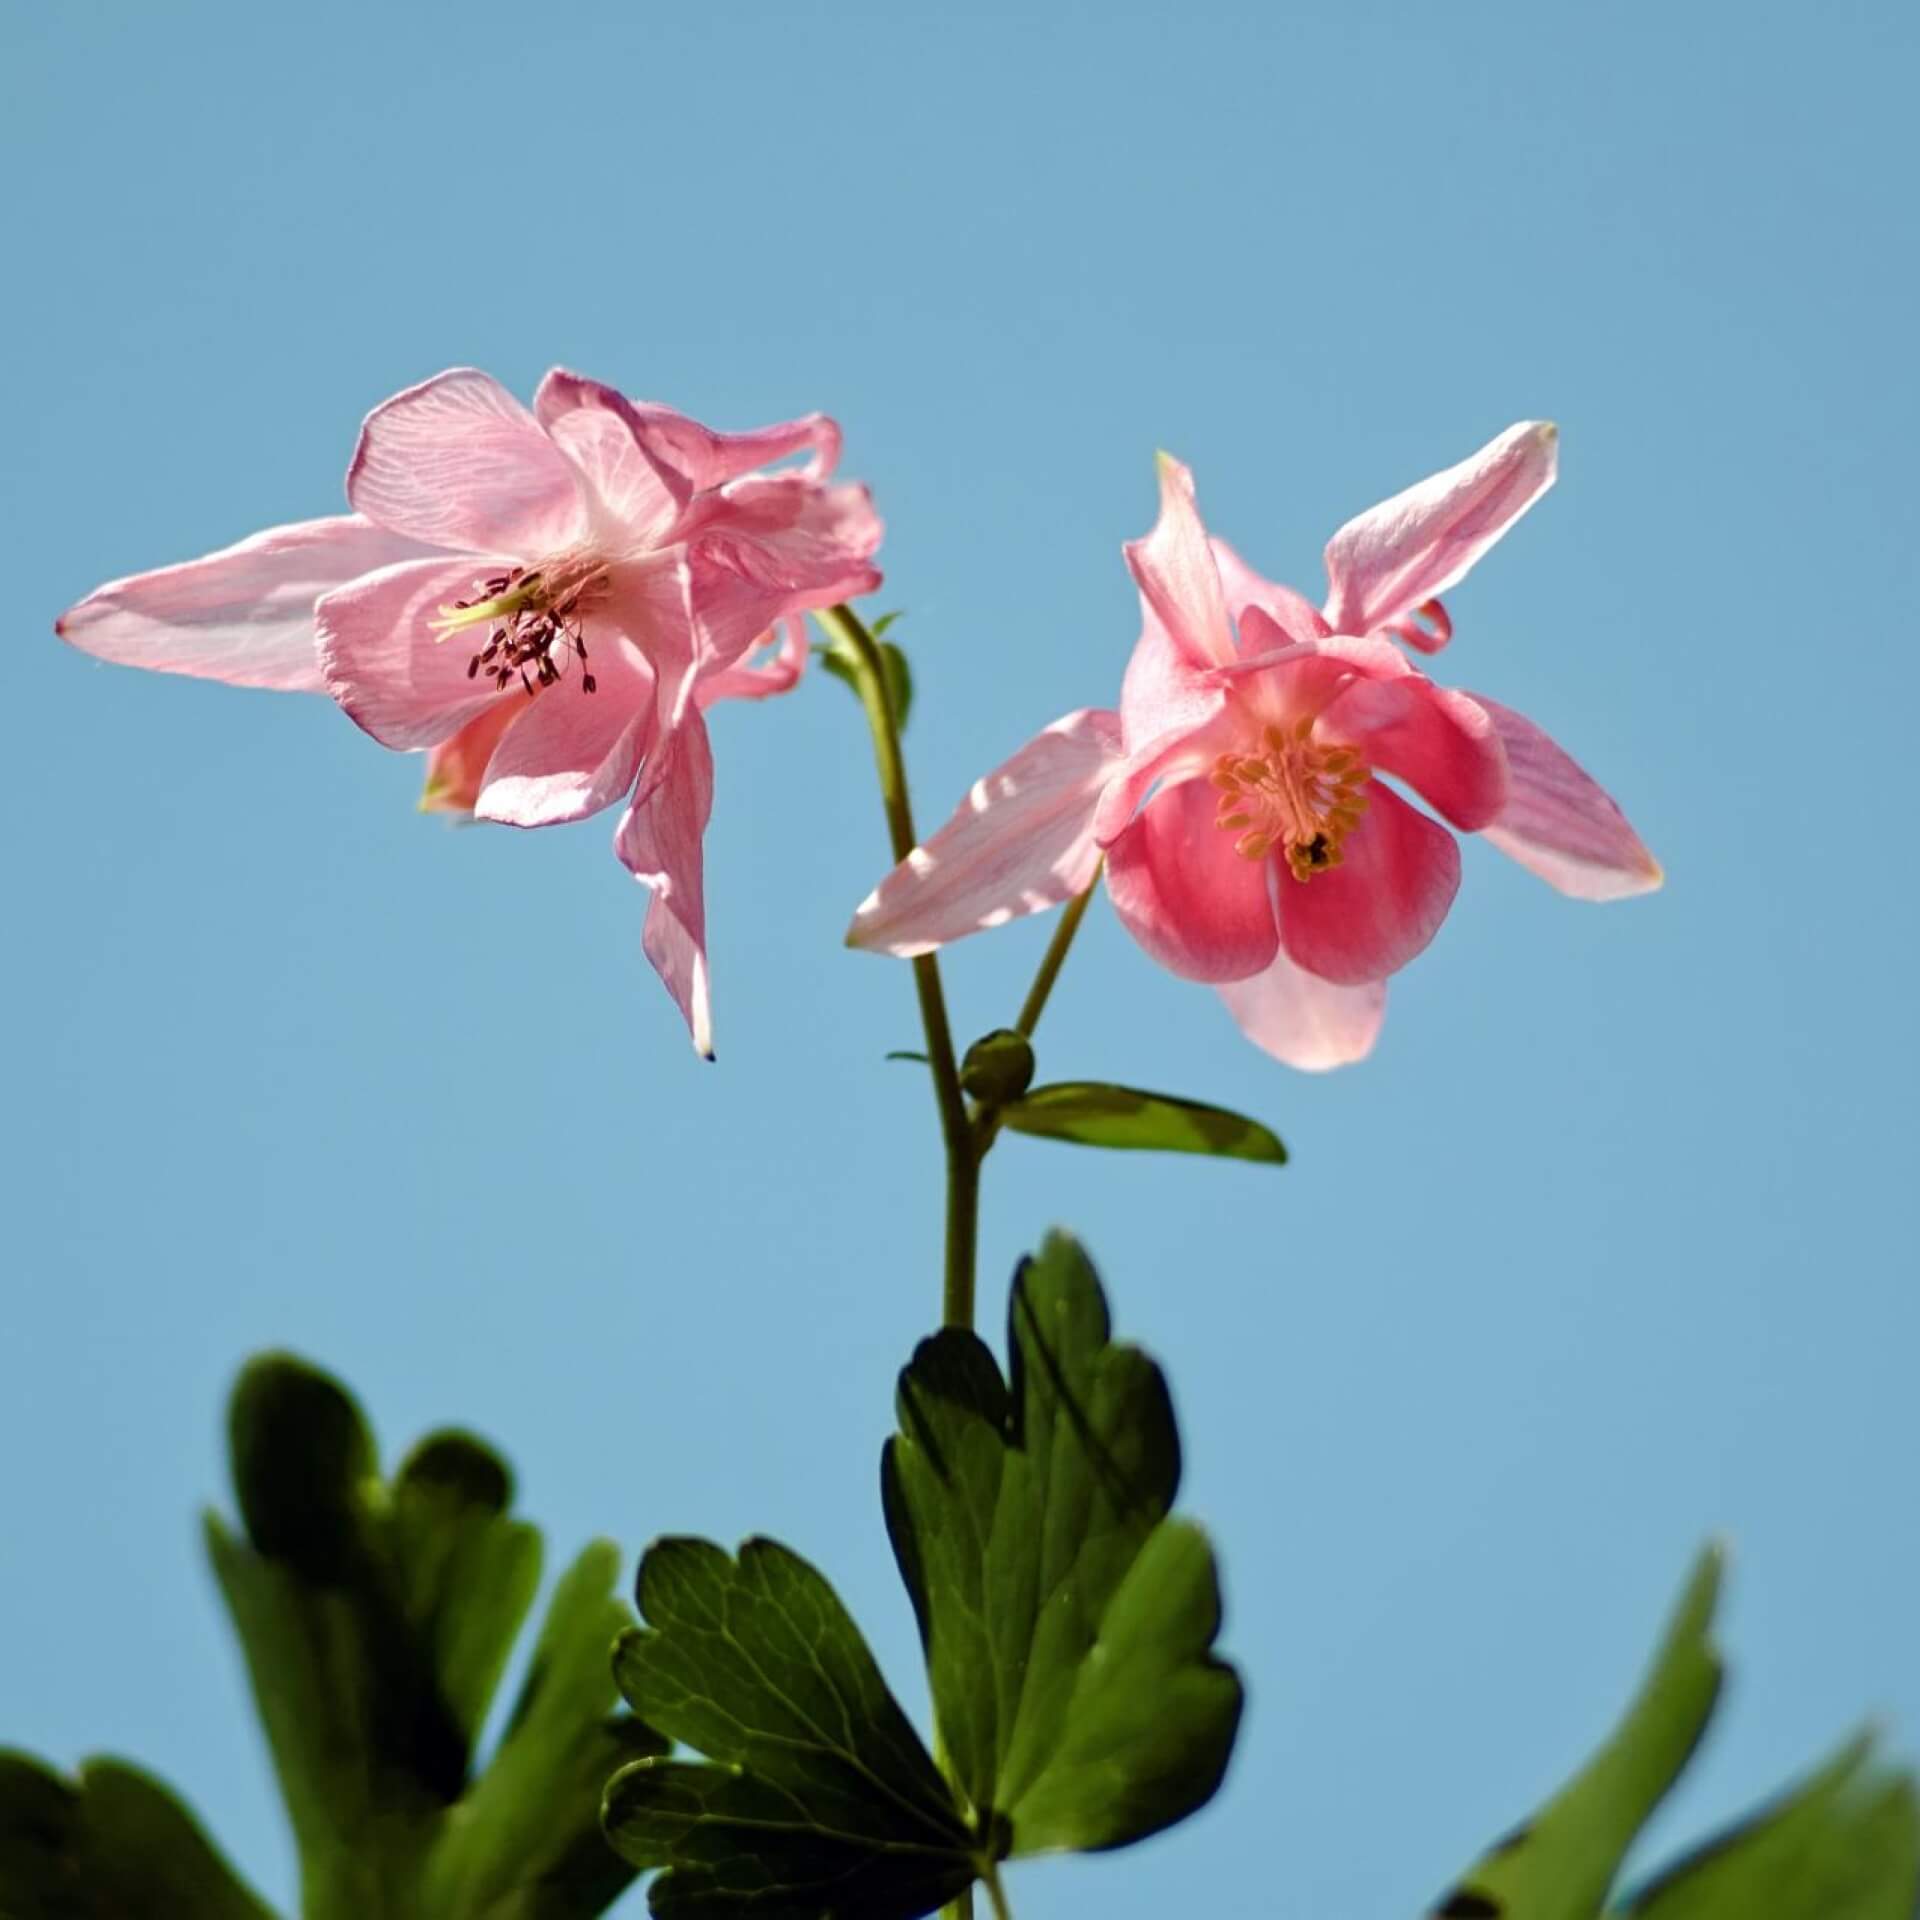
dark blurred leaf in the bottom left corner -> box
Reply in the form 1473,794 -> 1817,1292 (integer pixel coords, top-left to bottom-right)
0,1751 -> 273,1920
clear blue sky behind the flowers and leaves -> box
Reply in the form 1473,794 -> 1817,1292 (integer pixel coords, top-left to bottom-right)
0,0 -> 1920,1920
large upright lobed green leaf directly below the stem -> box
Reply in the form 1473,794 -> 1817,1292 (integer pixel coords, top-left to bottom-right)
881,1235 -> 1240,1859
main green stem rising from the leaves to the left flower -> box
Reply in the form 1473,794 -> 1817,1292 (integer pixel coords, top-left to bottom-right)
814,607 -> 979,1327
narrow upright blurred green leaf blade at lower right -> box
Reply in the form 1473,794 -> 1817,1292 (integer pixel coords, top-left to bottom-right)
1434,1548 -> 1722,1920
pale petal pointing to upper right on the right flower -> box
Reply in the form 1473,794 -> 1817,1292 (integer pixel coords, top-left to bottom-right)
1327,420 -> 1559,634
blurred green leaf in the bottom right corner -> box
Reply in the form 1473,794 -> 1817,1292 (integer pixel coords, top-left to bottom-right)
1620,1734 -> 1920,1920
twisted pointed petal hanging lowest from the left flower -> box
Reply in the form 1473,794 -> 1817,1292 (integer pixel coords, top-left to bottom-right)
612,712 -> 714,1060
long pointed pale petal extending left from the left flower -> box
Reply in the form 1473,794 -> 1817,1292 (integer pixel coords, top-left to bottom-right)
54,515 -> 430,693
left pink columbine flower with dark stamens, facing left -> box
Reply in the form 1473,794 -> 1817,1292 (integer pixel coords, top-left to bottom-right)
56,369 -> 881,1054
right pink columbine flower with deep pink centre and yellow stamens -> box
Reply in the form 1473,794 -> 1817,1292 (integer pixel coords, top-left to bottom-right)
847,422 -> 1661,1068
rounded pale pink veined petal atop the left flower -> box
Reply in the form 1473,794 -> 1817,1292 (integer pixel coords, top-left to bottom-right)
348,367 -> 588,559
